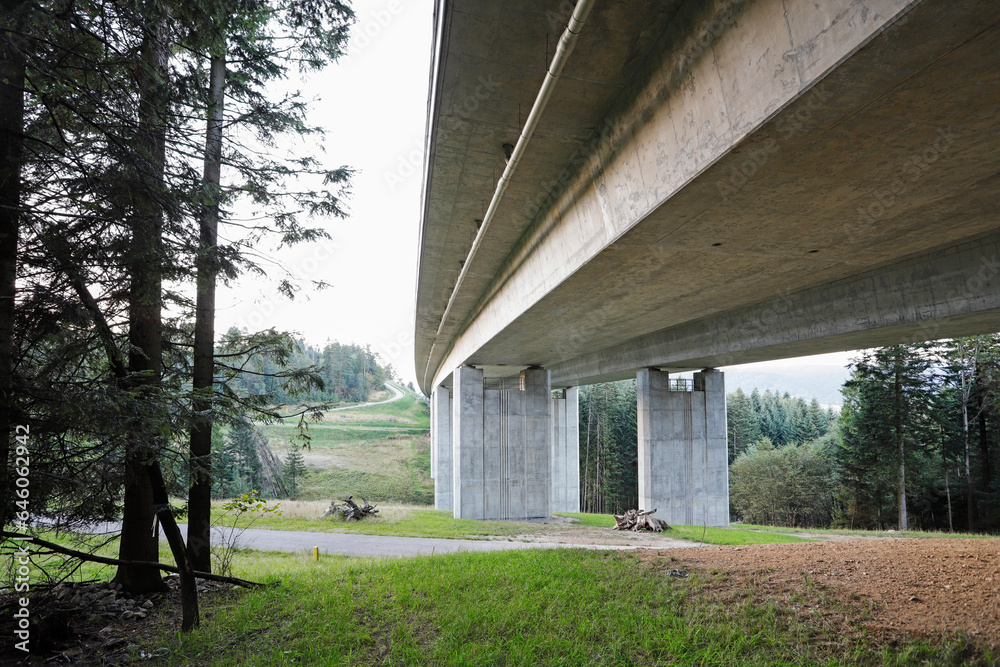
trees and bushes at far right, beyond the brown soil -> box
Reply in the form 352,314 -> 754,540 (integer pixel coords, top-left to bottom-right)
730,336 -> 1000,531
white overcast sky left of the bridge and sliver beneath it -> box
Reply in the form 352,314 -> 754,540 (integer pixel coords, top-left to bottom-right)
216,0 -> 854,392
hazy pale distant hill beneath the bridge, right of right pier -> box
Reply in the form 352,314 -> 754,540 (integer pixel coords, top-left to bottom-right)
723,364 -> 850,406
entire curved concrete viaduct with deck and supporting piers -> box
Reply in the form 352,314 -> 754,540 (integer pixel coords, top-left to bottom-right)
415,0 -> 1000,525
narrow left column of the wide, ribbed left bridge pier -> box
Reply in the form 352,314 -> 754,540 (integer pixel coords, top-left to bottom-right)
451,366 -> 485,519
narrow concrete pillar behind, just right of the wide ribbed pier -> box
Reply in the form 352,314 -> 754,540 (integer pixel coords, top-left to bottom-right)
552,387 -> 580,512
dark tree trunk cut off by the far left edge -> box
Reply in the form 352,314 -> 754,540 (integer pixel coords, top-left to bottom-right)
0,0 -> 24,526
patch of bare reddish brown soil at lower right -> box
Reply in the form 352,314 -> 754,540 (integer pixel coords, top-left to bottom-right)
644,538 -> 1000,646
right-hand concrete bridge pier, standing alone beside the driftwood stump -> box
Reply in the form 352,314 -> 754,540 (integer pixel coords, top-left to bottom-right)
636,369 -> 729,526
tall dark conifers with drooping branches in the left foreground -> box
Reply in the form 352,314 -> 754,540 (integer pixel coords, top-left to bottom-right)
0,0 -> 353,616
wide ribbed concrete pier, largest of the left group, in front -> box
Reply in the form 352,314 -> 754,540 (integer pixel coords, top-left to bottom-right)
452,366 -> 552,520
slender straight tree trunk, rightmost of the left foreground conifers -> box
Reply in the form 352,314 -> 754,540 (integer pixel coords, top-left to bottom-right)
188,55 -> 226,572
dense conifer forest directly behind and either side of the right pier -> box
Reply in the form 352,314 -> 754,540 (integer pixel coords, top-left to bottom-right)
580,380 -> 837,513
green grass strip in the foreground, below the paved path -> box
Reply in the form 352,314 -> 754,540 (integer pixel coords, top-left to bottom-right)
139,550 -> 994,666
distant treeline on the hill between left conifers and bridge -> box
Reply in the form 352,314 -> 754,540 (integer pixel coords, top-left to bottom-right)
230,340 -> 394,403
